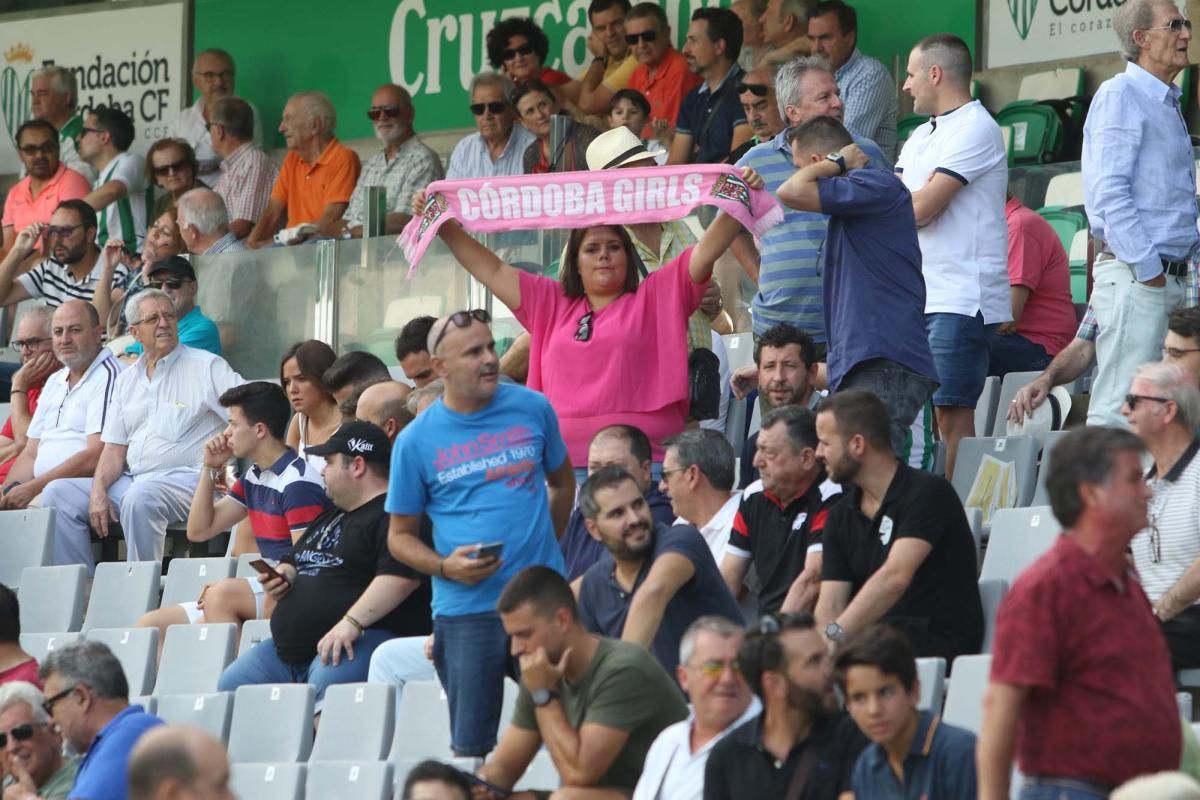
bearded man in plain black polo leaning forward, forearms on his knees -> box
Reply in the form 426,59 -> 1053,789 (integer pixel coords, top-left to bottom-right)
816,390 -> 983,663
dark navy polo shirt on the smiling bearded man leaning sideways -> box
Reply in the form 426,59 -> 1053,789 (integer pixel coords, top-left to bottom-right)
580,525 -> 742,675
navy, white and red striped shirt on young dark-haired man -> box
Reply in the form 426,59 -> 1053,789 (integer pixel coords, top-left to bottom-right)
229,447 -> 329,560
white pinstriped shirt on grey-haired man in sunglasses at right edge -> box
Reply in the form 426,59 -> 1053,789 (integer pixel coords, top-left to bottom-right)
1129,439 -> 1200,603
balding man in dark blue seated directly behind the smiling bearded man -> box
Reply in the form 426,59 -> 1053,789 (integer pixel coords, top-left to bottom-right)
558,425 -> 674,582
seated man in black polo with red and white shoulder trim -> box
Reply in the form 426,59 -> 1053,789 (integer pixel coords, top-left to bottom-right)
721,405 -> 841,614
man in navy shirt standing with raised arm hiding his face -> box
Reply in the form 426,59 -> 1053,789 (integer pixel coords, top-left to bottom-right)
778,116 -> 937,453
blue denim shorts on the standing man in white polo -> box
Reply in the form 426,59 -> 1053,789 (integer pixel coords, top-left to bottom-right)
925,313 -> 1000,408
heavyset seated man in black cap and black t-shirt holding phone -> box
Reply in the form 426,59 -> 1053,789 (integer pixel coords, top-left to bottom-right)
218,422 -> 432,711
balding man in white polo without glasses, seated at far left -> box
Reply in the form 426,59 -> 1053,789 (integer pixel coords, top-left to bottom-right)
0,300 -> 121,522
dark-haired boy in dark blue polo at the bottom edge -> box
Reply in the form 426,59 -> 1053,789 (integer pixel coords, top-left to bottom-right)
834,625 -> 976,800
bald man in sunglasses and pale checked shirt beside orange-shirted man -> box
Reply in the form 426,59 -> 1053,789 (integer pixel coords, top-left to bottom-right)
342,83 -> 445,237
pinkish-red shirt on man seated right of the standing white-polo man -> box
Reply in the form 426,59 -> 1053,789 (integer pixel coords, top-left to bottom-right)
1004,197 -> 1079,355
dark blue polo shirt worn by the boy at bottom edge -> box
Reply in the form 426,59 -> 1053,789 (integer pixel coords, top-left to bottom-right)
852,711 -> 976,800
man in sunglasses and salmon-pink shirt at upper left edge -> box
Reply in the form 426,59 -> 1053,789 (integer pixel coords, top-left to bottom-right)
0,119 -> 91,253
